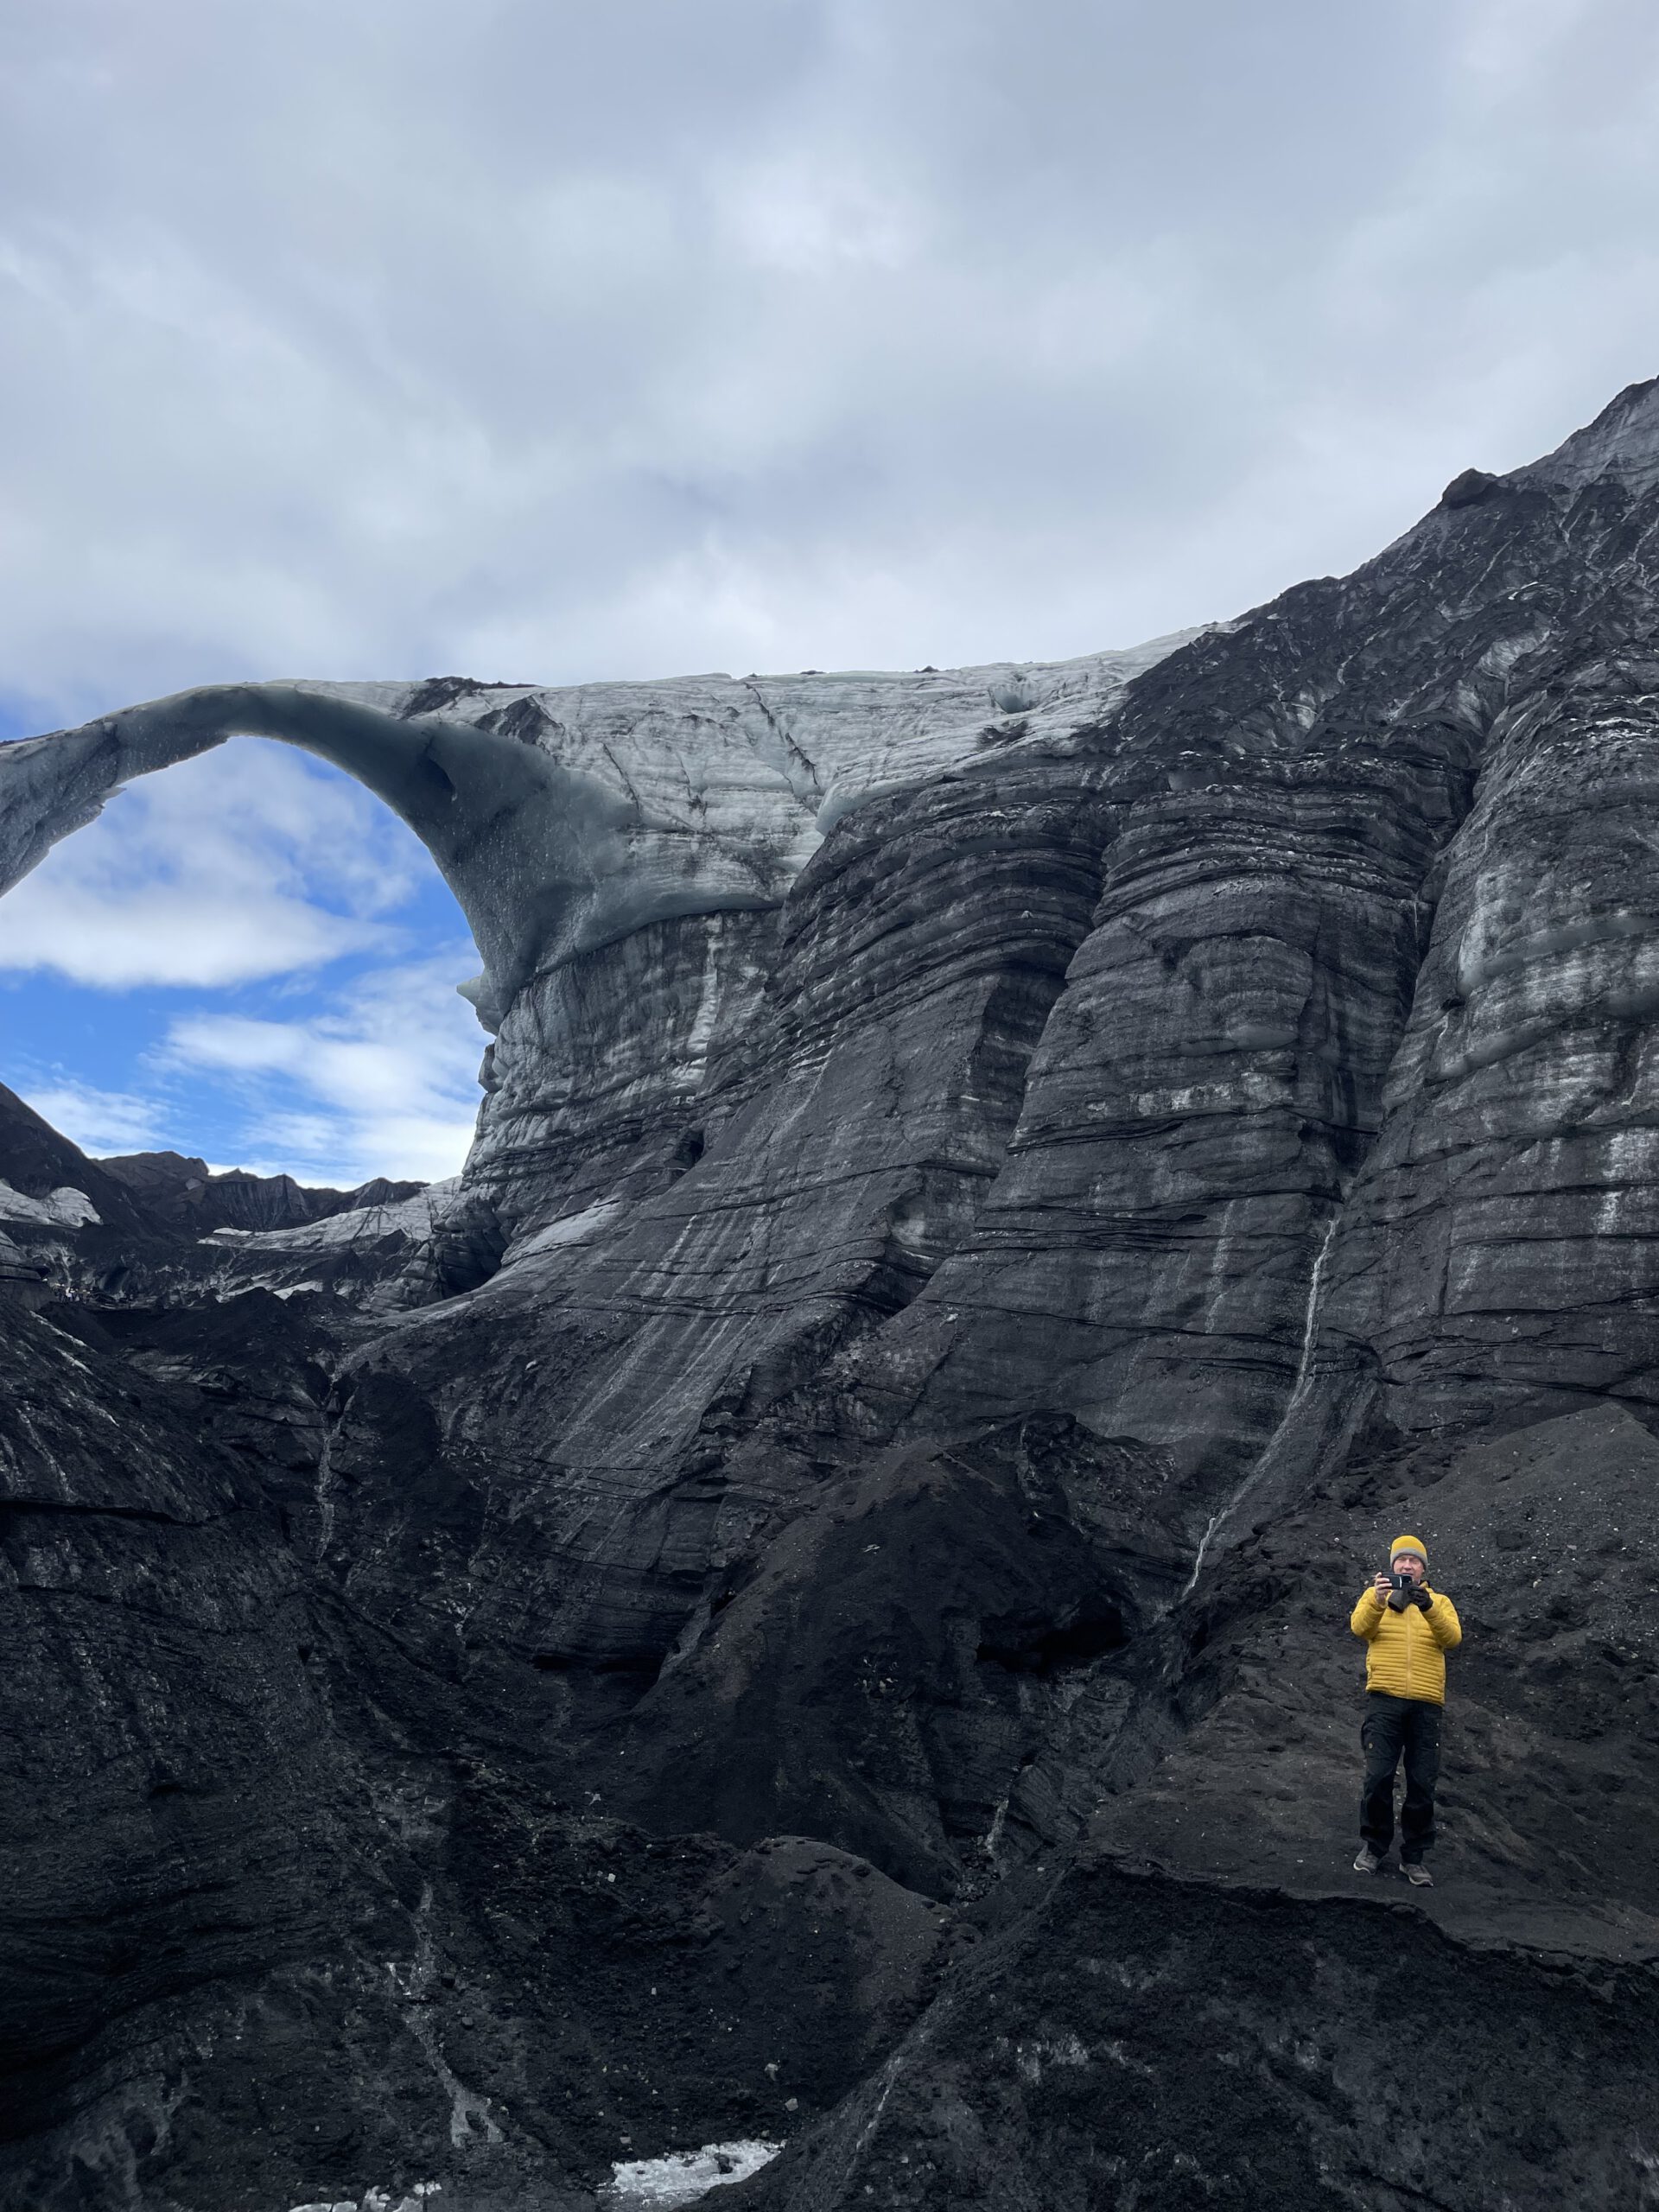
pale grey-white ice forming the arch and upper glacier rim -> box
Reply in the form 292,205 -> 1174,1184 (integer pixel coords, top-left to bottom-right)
0,631 -> 1199,1028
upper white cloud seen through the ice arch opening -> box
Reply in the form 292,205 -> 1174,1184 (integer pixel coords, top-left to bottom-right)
0,741 -> 429,991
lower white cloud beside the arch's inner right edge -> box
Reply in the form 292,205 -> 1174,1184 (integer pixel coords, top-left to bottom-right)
155,949 -> 482,1185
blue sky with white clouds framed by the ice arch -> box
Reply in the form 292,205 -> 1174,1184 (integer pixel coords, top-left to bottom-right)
0,706 -> 485,1184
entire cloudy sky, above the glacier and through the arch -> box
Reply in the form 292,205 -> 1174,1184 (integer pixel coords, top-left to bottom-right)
0,0 -> 1659,1173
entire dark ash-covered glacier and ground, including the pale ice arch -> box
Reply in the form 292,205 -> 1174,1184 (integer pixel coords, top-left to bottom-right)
0,385 -> 1659,2212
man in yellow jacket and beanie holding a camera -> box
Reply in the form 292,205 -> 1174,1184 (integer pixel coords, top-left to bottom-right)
1350,1535 -> 1462,1889
